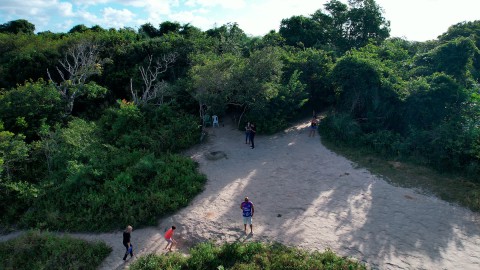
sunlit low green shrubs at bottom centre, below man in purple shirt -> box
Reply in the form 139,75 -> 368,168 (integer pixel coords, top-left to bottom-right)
130,242 -> 366,270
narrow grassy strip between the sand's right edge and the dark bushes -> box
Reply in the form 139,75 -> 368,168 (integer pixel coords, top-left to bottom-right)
322,139 -> 480,212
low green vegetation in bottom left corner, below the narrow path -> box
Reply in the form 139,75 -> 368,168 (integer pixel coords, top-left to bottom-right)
0,231 -> 112,269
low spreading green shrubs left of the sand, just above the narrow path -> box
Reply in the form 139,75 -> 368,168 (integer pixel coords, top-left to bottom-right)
21,152 -> 206,231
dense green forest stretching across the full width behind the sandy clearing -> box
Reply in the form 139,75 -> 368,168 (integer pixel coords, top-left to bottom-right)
0,0 -> 480,231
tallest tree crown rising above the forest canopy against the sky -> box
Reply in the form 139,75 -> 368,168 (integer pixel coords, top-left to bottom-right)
279,0 -> 390,53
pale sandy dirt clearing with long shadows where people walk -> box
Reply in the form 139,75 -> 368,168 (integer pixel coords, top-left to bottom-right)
0,119 -> 480,269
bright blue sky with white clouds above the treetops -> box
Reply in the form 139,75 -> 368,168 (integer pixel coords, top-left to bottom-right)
0,0 -> 480,41
